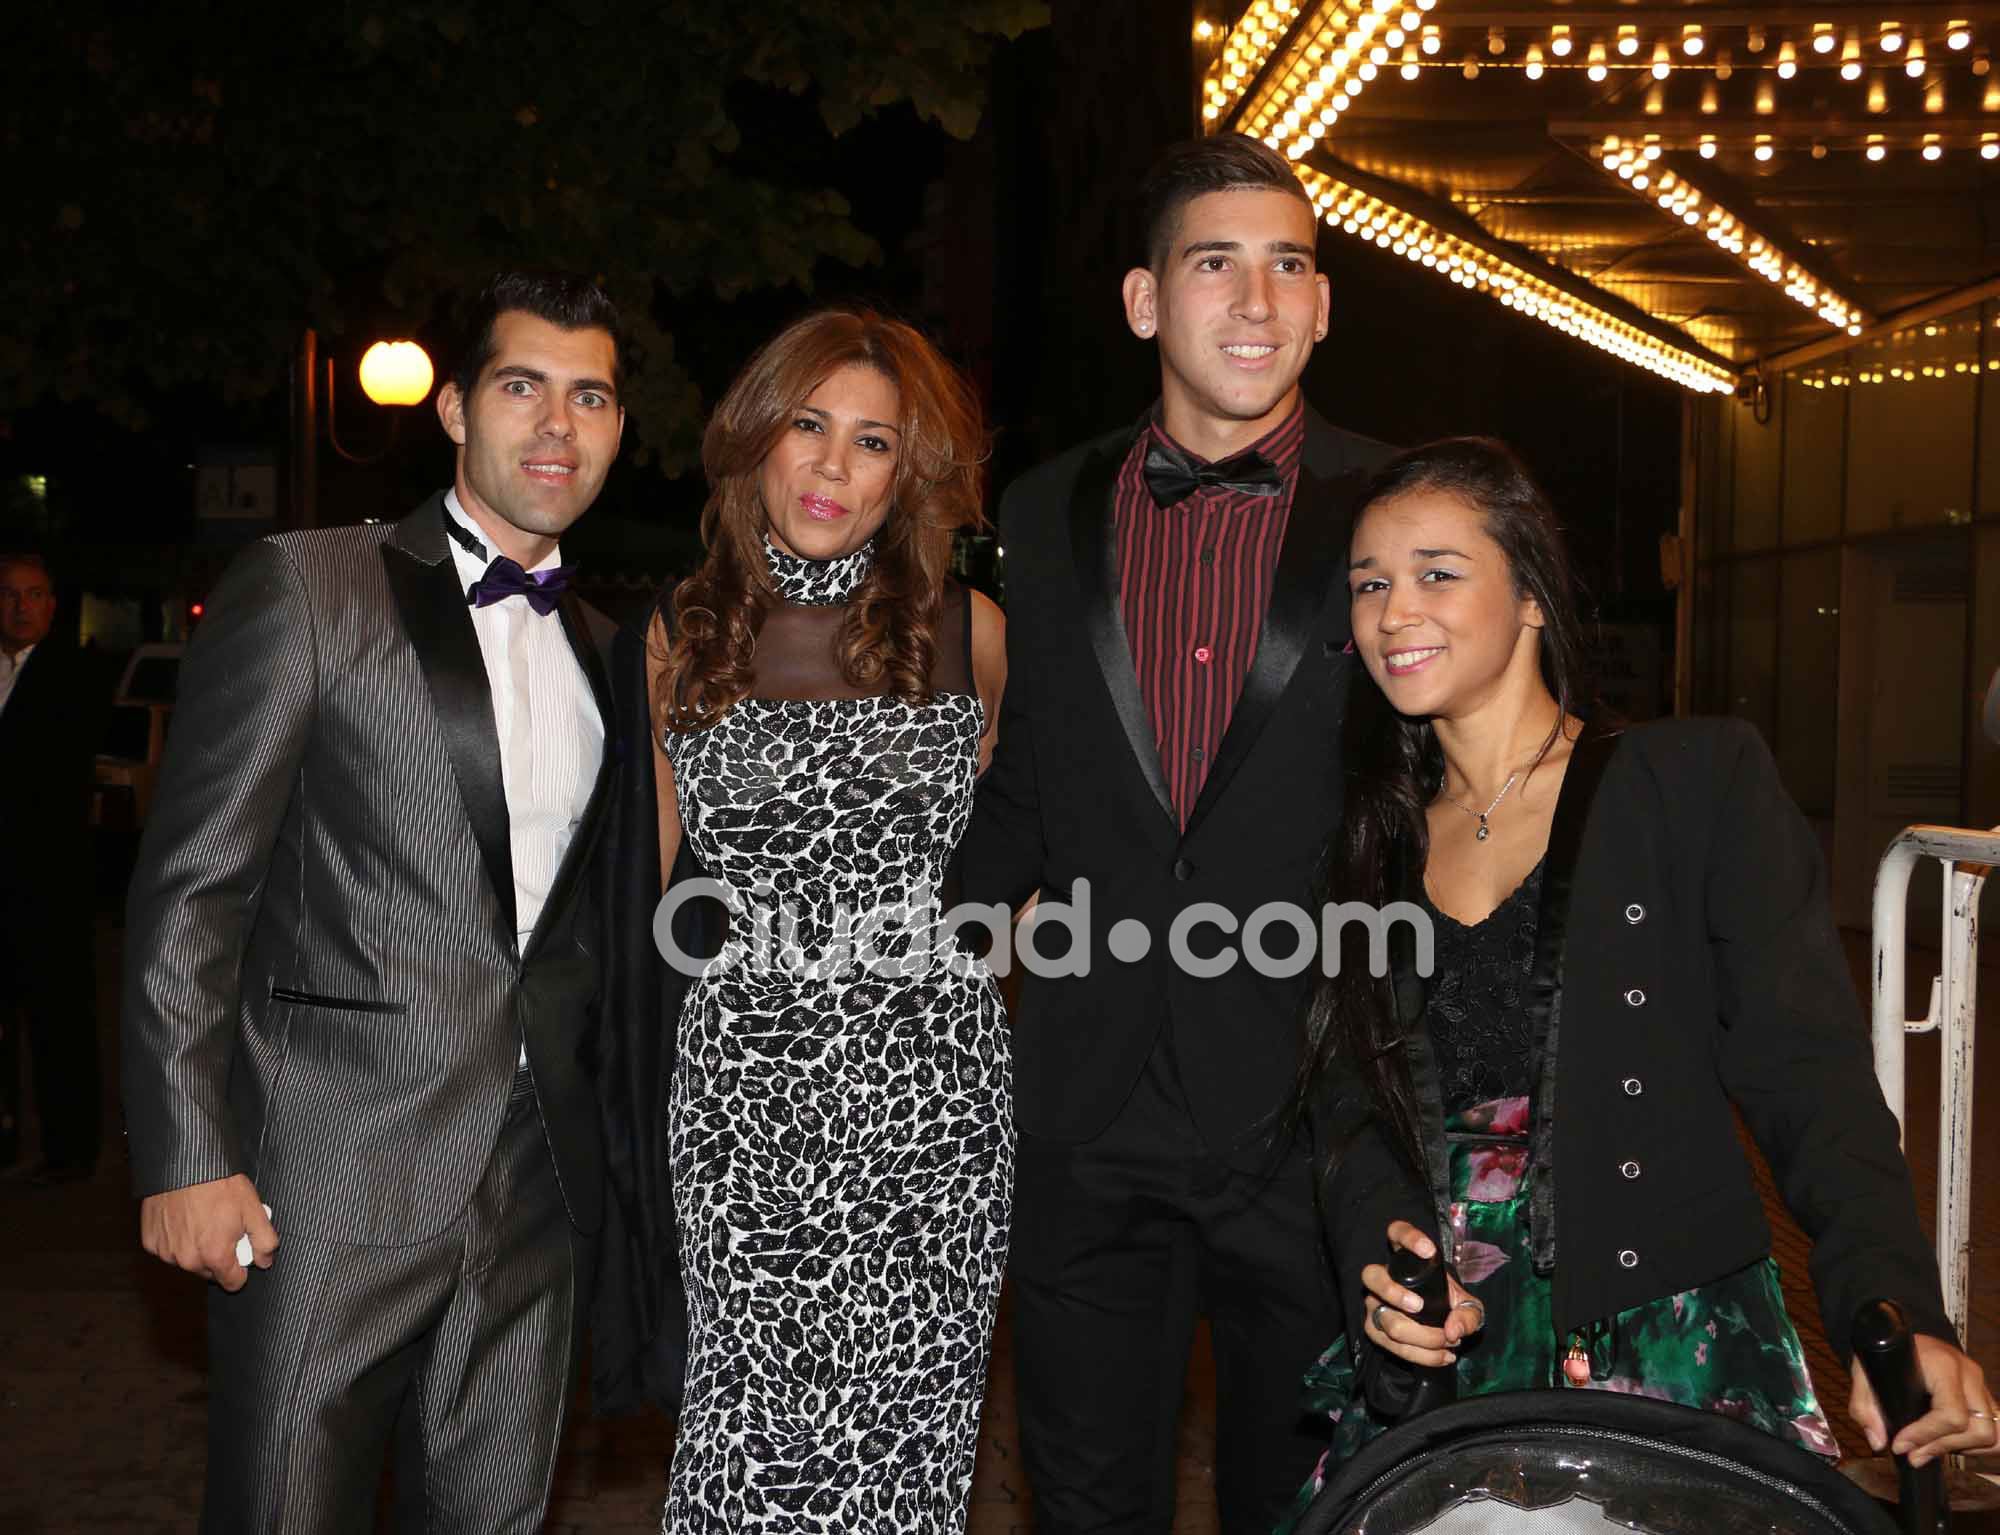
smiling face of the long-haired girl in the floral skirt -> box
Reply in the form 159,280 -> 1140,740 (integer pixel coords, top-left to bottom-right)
1348,488 -> 1542,720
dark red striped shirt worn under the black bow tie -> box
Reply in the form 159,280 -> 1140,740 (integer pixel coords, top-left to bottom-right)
1112,402 -> 1306,829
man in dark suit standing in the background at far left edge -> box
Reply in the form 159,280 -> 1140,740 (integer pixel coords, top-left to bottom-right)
0,554 -> 104,1183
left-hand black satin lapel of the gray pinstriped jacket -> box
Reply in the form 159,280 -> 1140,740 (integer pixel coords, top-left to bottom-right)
382,534 -> 514,943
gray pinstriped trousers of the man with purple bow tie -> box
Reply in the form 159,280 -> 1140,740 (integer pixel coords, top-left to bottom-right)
202,1071 -> 594,1535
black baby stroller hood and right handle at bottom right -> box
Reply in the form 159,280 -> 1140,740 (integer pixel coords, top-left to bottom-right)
1294,1301 -> 1948,1535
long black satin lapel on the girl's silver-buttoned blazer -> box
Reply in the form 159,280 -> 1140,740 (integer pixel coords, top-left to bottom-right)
1526,726 -> 1620,1273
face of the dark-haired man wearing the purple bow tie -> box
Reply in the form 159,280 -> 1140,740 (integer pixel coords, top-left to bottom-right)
438,310 -> 624,564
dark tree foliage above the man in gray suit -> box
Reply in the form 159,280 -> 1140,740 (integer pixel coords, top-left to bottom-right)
11,0 -> 1048,472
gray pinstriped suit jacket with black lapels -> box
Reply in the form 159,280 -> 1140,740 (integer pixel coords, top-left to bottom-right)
124,496 -> 616,1245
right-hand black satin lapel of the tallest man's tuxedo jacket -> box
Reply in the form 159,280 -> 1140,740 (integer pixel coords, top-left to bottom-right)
1188,466 -> 1362,833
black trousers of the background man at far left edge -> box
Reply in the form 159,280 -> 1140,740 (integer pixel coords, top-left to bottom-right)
0,875 -> 104,1171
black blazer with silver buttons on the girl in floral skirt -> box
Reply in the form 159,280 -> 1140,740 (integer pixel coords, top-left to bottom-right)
1326,720 -> 1952,1355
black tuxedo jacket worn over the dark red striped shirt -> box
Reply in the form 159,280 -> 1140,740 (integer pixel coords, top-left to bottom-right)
962,410 -> 1392,1157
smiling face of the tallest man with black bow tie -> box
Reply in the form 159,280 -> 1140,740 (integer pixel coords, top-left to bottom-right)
1126,188 -> 1330,458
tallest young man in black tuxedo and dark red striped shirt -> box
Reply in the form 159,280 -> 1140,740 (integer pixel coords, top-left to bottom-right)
964,136 -> 1390,1535
